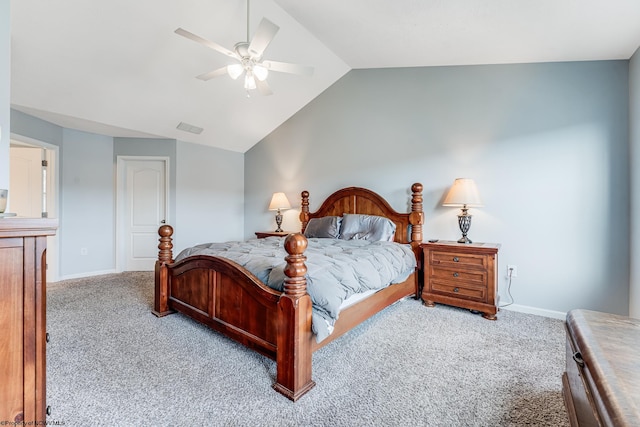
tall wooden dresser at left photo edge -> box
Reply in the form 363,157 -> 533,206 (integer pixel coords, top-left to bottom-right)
0,218 -> 58,425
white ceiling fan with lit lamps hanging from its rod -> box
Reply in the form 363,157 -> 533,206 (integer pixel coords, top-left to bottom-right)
175,0 -> 313,95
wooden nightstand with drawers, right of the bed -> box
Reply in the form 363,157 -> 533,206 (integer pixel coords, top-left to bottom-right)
420,241 -> 500,320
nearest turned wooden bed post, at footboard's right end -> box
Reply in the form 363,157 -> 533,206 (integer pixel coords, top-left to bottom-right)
273,233 -> 316,402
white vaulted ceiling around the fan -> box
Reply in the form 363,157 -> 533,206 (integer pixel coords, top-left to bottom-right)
11,0 -> 640,152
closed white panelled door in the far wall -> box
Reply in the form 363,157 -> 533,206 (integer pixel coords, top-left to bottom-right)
118,157 -> 168,271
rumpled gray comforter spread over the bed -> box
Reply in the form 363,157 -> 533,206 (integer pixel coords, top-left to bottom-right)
176,237 -> 416,342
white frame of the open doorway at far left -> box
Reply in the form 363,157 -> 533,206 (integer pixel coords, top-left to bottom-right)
9,132 -> 62,283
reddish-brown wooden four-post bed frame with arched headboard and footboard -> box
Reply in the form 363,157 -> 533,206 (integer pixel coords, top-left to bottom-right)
153,183 -> 424,401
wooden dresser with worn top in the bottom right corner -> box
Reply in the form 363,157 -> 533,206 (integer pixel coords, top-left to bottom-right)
562,310 -> 640,427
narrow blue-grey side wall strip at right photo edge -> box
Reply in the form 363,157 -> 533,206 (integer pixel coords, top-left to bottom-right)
629,49 -> 640,319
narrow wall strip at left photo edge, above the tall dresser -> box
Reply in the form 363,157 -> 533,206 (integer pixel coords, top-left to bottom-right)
0,0 -> 11,189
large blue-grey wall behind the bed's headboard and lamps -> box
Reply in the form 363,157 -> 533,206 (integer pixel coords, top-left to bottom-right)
245,61 -> 630,320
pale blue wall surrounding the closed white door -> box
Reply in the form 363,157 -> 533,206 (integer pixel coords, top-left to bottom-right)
11,110 -> 244,279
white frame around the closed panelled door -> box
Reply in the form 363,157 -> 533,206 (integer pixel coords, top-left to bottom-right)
115,156 -> 171,273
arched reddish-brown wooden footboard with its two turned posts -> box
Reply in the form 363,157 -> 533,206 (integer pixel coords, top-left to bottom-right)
153,225 -> 315,401
